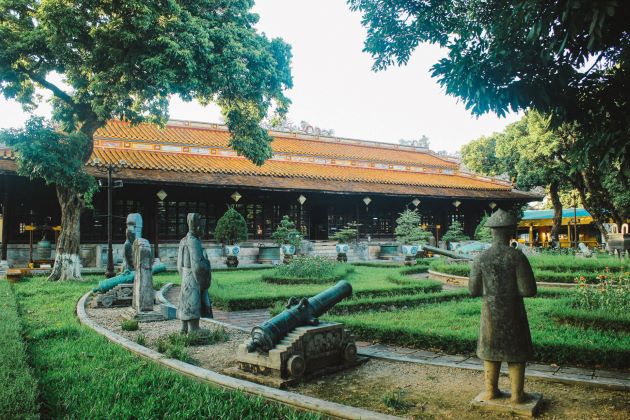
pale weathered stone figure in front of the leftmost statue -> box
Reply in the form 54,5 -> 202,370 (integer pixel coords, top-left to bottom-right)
131,238 -> 155,313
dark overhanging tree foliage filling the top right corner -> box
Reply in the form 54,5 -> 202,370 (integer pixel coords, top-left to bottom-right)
348,0 -> 630,171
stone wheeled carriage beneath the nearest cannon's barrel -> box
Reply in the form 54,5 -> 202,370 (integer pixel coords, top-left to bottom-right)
225,322 -> 367,389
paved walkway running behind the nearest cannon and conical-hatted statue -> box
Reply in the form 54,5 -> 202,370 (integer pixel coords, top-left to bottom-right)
164,284 -> 630,391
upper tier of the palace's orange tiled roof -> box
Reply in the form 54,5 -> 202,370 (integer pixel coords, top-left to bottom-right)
95,121 -> 457,169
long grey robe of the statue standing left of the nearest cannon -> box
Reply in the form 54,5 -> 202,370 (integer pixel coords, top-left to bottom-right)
177,232 -> 210,321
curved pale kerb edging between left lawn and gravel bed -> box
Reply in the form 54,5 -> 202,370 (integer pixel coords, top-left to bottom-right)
76,292 -> 399,420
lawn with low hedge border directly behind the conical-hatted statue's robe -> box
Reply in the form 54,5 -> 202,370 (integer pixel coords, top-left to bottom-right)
326,298 -> 630,368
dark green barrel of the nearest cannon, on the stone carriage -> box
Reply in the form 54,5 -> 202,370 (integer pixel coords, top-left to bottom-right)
247,280 -> 352,353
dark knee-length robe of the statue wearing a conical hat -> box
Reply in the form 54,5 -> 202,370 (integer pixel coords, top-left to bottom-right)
468,244 -> 536,363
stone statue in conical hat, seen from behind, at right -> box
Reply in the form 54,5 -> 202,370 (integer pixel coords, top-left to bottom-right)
469,209 -> 536,404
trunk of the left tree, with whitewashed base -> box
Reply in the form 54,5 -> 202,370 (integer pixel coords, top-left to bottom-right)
48,185 -> 84,281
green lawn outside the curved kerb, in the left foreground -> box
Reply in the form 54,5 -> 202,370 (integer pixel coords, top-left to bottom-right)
11,278 -> 317,419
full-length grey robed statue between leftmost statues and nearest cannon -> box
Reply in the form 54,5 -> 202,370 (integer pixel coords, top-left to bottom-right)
177,213 -> 212,334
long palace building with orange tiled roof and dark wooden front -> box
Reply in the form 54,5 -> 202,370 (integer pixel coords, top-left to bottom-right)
0,121 -> 540,265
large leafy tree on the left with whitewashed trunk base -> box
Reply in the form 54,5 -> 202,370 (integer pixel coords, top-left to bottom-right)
0,0 -> 292,279
